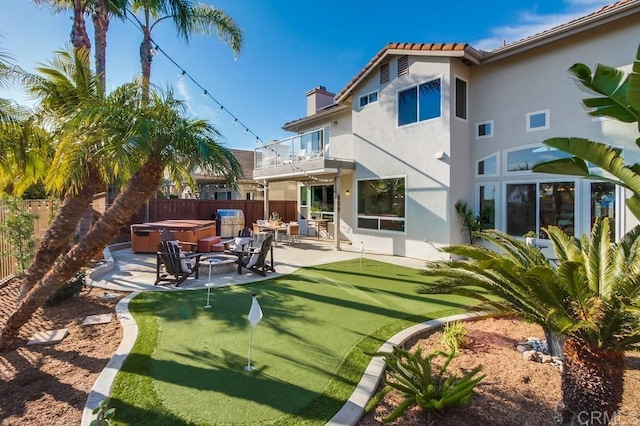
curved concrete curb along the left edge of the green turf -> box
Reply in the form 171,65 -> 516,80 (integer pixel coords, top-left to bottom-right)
80,291 -> 141,426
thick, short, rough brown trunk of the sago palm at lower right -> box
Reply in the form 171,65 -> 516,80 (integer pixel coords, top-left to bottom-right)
562,338 -> 624,425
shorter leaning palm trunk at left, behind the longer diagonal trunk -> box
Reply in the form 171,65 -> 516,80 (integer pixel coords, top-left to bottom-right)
18,165 -> 104,301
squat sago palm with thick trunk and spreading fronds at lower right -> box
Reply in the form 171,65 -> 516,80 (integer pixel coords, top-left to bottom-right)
423,218 -> 640,423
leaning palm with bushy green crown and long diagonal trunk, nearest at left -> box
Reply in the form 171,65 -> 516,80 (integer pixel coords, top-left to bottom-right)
0,84 -> 242,348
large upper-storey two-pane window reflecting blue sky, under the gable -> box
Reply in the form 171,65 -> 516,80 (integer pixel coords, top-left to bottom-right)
398,78 -> 441,126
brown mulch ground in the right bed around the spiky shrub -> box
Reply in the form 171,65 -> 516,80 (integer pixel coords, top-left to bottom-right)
359,318 -> 640,426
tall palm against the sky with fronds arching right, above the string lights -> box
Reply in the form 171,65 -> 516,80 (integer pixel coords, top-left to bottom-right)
131,0 -> 244,98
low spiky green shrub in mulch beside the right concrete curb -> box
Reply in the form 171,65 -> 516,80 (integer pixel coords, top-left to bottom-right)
376,346 -> 484,424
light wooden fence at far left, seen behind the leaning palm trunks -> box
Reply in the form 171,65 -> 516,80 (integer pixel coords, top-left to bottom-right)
0,200 -> 57,281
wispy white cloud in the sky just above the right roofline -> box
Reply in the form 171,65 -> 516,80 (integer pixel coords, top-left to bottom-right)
471,0 -> 612,50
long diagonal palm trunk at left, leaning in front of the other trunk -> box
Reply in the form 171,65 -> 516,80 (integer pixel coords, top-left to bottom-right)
0,160 -> 163,349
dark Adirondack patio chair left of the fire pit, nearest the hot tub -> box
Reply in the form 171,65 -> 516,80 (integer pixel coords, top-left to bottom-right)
153,241 -> 202,287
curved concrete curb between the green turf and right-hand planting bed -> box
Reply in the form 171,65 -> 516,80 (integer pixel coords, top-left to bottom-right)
327,312 -> 488,426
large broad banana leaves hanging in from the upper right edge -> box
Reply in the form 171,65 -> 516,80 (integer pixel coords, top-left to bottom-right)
533,46 -> 640,220
